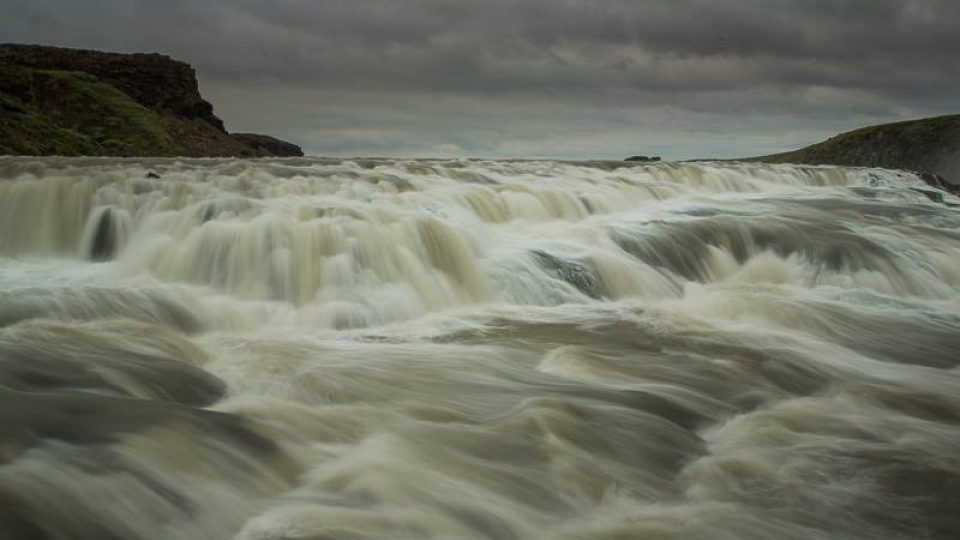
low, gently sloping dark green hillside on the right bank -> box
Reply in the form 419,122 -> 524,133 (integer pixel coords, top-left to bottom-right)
741,115 -> 960,193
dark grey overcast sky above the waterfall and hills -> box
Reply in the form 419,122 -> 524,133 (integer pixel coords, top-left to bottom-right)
0,0 -> 960,159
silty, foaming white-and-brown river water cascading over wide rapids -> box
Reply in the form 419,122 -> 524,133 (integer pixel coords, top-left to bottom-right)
0,158 -> 960,540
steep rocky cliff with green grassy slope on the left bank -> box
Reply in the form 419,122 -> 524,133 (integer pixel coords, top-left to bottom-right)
0,44 -> 303,157
